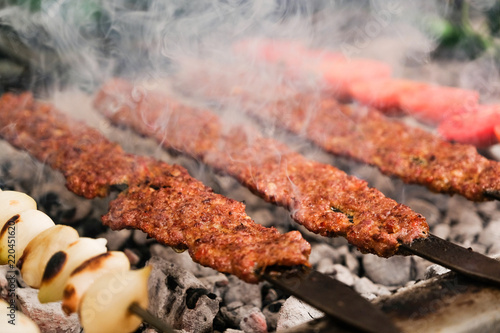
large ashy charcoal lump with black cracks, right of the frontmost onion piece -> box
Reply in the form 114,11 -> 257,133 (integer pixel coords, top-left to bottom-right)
149,257 -> 220,333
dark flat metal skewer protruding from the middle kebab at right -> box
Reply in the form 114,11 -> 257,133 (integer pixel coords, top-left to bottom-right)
400,235 -> 500,285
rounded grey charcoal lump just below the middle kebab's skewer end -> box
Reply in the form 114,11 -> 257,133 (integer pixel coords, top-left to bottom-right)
363,254 -> 411,286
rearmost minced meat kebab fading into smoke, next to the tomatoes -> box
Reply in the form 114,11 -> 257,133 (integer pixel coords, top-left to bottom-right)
171,65 -> 500,201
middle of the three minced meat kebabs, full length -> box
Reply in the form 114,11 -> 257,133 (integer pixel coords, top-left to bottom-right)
95,79 -> 428,256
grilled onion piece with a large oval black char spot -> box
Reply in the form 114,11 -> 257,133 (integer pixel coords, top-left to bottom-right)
38,237 -> 106,303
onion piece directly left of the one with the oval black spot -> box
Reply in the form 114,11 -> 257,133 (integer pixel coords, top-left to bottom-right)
17,225 -> 79,288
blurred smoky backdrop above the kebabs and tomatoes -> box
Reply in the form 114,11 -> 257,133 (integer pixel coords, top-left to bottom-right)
0,0 -> 500,94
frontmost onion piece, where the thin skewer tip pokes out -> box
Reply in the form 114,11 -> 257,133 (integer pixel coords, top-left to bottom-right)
78,266 -> 151,333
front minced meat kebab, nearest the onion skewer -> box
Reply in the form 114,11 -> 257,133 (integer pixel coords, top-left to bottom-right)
0,94 -> 310,283
